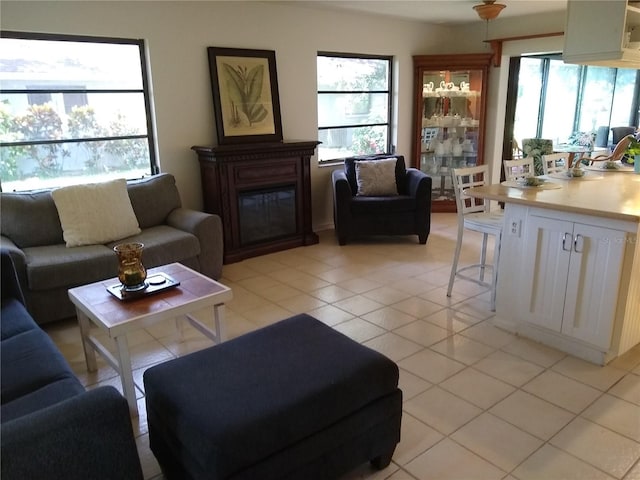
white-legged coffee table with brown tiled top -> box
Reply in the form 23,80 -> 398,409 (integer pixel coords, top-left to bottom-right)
69,263 -> 233,415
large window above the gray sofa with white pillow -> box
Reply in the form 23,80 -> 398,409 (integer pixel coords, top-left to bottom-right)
0,32 -> 158,191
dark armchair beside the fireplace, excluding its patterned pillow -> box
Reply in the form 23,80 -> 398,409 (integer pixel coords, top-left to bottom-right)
332,155 -> 431,245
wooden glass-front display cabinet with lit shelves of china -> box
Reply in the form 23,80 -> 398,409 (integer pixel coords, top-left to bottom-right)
412,53 -> 492,212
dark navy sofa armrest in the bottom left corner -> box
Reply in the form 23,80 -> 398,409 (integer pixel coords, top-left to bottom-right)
0,387 -> 143,480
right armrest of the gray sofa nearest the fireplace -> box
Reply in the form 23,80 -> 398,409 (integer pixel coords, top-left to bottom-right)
167,208 -> 224,280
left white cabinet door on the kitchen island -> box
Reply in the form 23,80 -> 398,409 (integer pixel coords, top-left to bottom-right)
514,215 -> 573,332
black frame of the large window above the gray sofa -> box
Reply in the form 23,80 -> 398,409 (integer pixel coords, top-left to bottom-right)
0,30 -> 160,191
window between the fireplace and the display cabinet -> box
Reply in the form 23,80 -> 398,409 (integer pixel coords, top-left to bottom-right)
318,52 -> 392,162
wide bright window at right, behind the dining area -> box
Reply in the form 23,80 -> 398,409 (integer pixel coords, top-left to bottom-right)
514,55 -> 640,143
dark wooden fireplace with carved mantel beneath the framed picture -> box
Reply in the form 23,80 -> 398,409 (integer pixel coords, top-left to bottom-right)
191,140 -> 320,263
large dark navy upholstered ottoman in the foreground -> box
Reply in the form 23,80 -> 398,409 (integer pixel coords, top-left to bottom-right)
144,315 -> 402,480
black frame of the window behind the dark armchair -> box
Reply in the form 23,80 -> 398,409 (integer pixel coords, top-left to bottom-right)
316,51 -> 394,165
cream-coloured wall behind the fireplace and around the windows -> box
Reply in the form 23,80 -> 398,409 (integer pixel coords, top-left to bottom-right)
0,0 -> 564,229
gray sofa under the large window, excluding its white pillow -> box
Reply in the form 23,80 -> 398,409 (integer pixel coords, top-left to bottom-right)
0,173 -> 223,324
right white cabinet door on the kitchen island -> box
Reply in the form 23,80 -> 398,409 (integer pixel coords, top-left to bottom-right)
562,223 -> 625,349
